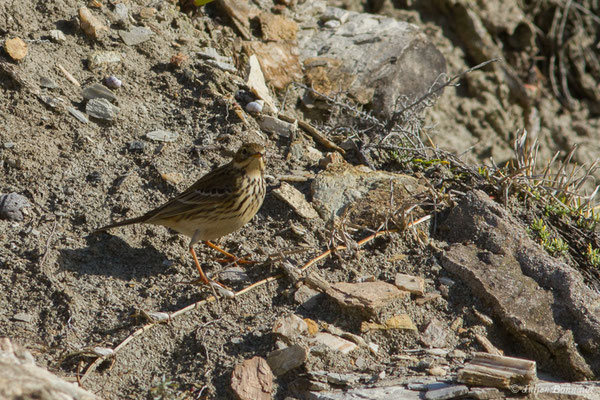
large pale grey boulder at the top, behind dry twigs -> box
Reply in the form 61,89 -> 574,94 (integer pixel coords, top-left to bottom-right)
298,7 -> 446,118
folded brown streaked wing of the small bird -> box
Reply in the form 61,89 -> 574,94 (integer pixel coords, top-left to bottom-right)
145,164 -> 239,222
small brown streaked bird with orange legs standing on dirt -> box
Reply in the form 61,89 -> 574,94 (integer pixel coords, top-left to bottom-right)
96,143 -> 266,284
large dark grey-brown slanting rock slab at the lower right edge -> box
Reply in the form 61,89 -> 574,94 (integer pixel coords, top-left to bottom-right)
440,190 -> 600,380
